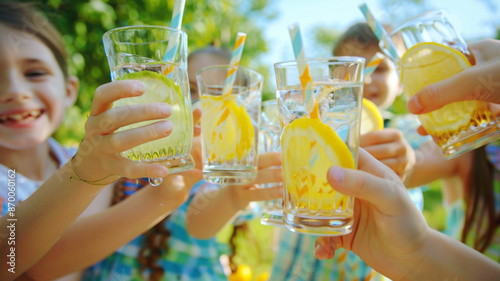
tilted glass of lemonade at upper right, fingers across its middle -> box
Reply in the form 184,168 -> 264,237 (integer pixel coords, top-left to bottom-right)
380,11 -> 500,159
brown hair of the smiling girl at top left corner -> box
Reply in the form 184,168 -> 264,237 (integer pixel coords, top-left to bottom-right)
0,2 -> 68,78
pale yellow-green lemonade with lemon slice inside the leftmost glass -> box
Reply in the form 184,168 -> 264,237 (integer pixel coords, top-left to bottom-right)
112,62 -> 193,166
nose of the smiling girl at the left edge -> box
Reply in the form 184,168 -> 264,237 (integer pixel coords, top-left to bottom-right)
0,72 -> 31,103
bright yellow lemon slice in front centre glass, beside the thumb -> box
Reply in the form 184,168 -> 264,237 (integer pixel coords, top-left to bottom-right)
281,117 -> 354,212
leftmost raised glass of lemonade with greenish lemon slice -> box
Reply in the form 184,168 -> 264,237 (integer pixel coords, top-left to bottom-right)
103,26 -> 194,185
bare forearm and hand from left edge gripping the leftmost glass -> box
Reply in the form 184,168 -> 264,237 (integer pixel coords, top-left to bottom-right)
0,80 -> 172,280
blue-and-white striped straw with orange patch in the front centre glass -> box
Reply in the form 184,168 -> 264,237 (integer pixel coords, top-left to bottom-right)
288,23 -> 316,114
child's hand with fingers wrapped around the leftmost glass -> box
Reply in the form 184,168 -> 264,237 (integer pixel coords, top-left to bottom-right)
72,80 -> 172,184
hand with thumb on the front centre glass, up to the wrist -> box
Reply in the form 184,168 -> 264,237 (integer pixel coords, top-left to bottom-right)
316,149 -> 429,280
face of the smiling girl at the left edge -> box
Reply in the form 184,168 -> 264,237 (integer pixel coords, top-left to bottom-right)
0,24 -> 78,150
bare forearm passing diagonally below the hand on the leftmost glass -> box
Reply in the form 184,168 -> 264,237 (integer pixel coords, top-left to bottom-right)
27,170 -> 202,280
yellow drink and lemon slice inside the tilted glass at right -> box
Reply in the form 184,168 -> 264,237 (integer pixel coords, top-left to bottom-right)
400,42 -> 498,157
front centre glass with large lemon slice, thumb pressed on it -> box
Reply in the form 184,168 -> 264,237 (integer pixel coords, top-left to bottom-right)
274,57 -> 365,235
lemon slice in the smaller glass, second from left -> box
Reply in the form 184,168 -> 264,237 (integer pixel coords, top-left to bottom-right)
201,95 -> 255,163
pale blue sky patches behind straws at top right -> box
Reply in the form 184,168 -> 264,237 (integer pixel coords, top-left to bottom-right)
257,0 -> 500,88
